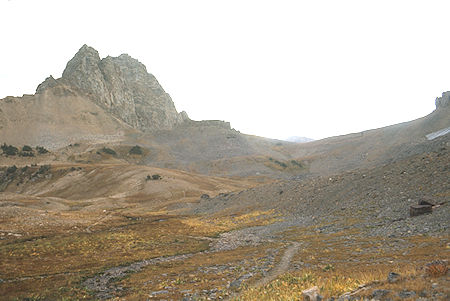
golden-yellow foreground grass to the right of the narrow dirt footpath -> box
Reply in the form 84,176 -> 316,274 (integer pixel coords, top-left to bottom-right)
236,227 -> 449,300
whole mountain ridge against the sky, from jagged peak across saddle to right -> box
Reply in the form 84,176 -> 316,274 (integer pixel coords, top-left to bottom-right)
0,45 -> 450,177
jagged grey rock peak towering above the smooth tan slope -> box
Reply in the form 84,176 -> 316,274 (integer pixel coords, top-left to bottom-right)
36,45 -> 189,131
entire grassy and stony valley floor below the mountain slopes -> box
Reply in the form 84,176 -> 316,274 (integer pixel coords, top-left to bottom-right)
0,141 -> 450,300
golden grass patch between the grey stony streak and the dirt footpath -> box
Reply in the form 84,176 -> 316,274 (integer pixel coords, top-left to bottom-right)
119,244 -> 280,300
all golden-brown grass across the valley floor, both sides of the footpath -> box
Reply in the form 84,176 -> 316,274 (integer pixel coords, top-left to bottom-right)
0,206 -> 449,300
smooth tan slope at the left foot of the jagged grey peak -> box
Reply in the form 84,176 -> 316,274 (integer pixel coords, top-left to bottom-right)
0,85 -> 134,148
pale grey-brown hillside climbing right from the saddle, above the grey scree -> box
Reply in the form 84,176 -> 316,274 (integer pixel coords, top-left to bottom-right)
285,102 -> 450,174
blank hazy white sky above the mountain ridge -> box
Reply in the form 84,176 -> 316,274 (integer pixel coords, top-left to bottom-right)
0,0 -> 450,139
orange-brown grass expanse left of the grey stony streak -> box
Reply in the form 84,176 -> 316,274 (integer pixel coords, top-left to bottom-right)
0,211 -> 282,300
